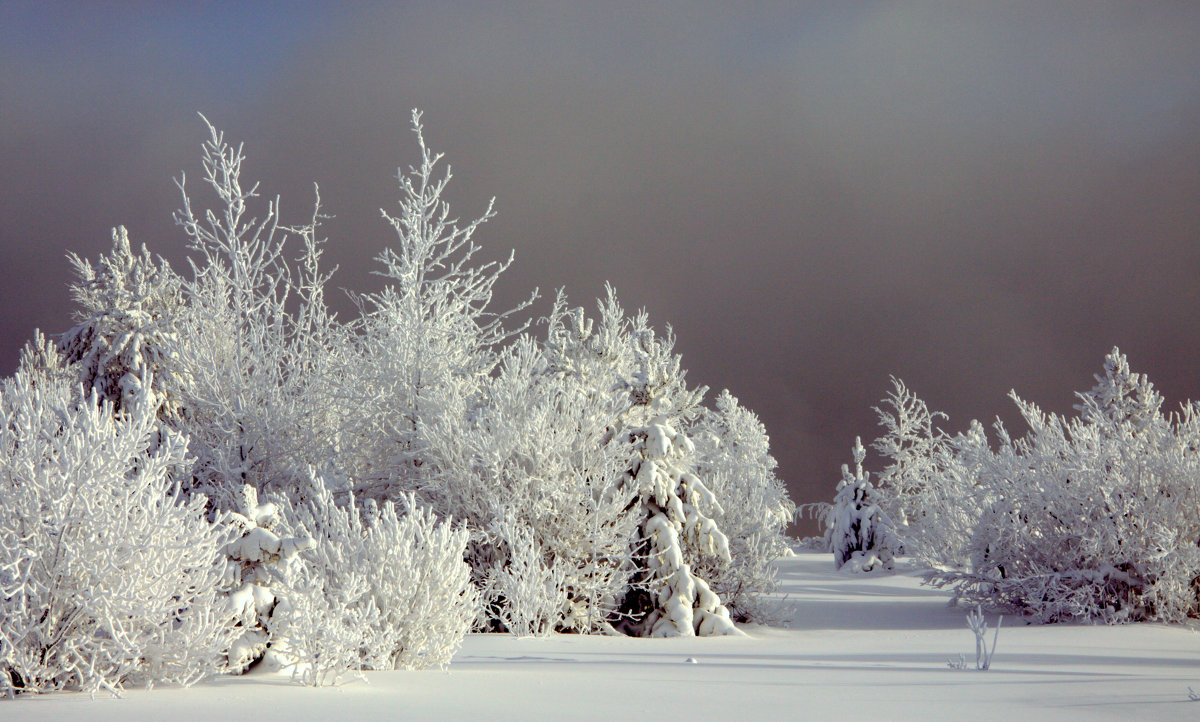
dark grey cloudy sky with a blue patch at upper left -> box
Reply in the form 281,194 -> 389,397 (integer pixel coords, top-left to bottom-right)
0,0 -> 1200,530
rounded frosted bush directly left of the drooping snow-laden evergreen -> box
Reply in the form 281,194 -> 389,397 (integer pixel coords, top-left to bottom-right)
425,337 -> 636,633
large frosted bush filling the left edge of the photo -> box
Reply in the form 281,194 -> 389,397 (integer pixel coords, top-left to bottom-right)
0,339 -> 238,696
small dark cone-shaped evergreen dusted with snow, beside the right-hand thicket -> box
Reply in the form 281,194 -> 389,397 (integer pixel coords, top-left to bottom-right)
826,439 -> 904,572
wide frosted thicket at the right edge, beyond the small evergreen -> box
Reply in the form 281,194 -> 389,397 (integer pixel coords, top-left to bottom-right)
877,349 -> 1200,622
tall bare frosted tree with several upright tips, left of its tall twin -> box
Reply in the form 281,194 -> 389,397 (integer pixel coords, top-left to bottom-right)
164,115 -> 352,509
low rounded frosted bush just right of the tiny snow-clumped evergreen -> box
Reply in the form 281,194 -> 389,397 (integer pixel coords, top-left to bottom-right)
271,474 -> 478,684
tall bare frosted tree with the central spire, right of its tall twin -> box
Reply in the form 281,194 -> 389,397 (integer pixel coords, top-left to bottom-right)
346,110 -> 536,499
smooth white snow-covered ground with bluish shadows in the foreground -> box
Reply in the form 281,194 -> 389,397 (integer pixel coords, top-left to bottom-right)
0,553 -> 1200,722
